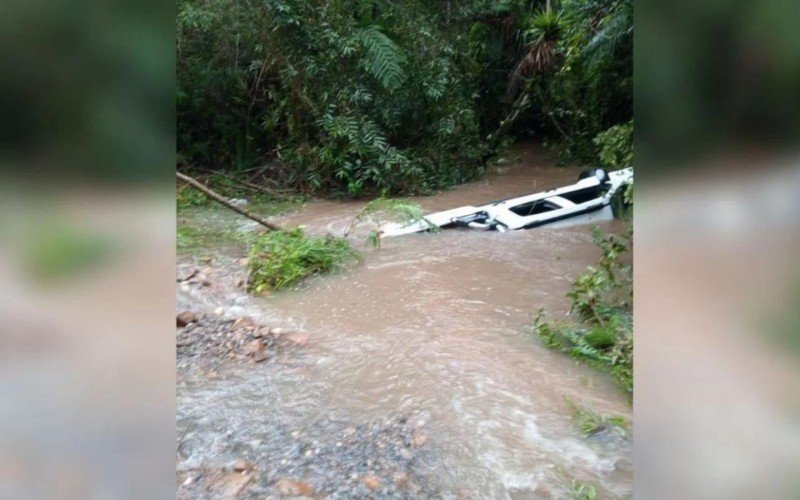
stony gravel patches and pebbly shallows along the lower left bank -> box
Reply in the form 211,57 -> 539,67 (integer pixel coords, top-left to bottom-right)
176,260 -> 440,499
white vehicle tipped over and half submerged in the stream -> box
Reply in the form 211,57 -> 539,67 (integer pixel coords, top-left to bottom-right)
381,168 -> 633,237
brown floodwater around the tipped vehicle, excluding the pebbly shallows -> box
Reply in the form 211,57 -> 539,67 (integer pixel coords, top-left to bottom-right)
179,146 -> 632,498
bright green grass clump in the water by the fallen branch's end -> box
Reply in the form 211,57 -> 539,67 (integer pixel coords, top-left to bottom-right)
247,228 -> 358,293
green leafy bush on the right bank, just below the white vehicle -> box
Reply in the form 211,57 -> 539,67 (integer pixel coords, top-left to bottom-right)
533,225 -> 633,392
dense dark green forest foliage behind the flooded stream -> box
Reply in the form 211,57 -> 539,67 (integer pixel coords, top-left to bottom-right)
177,0 -> 633,196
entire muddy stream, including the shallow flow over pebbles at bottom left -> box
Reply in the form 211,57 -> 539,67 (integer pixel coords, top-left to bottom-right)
177,149 -> 633,498
